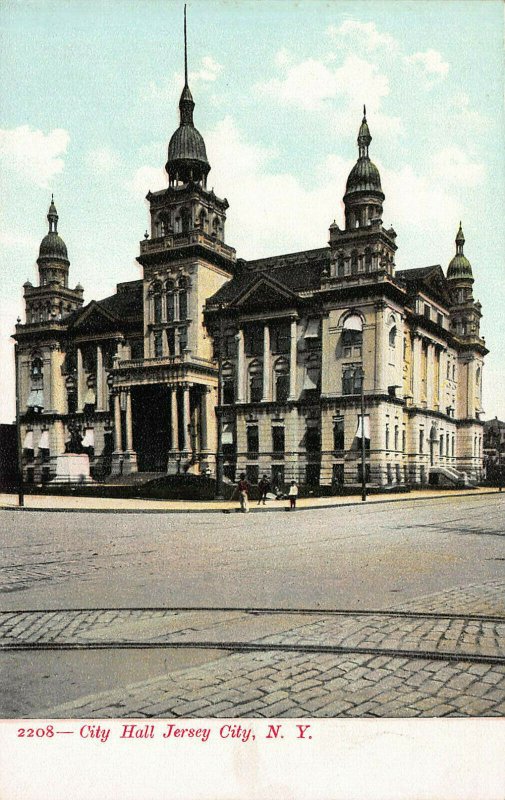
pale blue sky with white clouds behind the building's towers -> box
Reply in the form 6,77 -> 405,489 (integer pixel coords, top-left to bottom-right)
0,0 -> 505,421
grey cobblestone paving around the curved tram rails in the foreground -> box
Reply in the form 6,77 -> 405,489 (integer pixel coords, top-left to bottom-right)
0,581 -> 505,718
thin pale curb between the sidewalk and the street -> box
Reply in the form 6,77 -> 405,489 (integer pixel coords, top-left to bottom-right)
0,489 -> 500,514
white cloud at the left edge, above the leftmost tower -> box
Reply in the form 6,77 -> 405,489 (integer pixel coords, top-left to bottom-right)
0,125 -> 70,188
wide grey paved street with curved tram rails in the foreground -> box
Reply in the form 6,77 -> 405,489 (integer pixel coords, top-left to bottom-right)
0,494 -> 505,717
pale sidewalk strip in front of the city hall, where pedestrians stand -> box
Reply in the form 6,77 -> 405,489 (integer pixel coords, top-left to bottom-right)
0,487 -> 498,514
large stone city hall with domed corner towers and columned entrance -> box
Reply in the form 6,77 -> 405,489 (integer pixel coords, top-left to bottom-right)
14,48 -> 487,491
